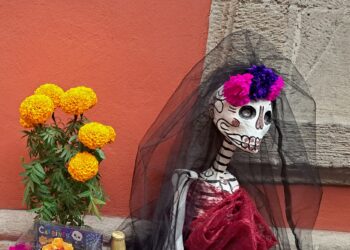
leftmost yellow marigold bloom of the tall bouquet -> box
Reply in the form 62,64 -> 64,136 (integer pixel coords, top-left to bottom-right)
19,95 -> 55,125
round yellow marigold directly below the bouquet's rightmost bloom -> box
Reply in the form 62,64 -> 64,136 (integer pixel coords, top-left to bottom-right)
68,152 -> 98,182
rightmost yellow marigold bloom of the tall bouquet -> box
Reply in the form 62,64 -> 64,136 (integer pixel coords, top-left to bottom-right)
78,122 -> 115,149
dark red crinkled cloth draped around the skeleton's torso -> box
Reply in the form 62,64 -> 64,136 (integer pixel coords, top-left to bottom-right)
185,189 -> 277,250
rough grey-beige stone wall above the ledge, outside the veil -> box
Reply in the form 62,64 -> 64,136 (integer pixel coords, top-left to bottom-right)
207,0 -> 350,170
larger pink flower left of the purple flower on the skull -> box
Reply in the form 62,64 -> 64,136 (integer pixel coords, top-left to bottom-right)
224,73 -> 254,107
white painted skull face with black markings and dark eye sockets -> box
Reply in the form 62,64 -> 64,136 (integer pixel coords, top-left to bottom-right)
212,87 -> 272,153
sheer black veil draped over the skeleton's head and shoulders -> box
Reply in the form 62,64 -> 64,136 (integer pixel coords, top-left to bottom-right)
120,31 -> 322,249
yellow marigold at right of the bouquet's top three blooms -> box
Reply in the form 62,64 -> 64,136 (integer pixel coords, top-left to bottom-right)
61,86 -> 97,115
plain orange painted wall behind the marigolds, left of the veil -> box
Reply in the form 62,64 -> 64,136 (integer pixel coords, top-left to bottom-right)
0,0 -> 210,214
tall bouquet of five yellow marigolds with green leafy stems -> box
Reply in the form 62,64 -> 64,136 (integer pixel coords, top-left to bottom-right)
19,83 -> 115,226
